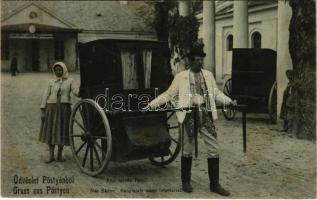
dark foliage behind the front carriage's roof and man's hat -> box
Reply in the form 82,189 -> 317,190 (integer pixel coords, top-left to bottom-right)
135,0 -> 203,57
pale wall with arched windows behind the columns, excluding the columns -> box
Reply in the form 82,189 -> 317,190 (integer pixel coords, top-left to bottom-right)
197,1 -> 278,84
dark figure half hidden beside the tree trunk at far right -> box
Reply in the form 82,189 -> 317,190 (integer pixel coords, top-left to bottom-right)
280,70 -> 293,131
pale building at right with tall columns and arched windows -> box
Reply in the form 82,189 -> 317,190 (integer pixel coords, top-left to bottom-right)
197,0 -> 293,116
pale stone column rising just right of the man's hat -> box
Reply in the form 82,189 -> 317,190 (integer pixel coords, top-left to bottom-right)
203,1 -> 216,76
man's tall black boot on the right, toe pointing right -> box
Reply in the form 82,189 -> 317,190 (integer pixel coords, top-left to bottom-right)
208,158 -> 230,196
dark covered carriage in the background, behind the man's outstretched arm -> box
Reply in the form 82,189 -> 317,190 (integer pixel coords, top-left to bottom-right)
222,48 -> 277,123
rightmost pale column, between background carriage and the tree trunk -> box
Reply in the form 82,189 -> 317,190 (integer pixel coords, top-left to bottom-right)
276,1 -> 293,116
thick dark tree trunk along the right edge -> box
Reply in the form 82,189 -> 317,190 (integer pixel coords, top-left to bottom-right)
289,0 -> 316,140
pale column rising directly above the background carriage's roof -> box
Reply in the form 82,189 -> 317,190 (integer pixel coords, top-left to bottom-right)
233,0 -> 249,48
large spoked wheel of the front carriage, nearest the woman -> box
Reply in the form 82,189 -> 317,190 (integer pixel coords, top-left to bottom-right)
69,99 -> 112,176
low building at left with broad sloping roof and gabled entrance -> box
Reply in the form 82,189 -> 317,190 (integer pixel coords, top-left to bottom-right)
1,1 -> 156,72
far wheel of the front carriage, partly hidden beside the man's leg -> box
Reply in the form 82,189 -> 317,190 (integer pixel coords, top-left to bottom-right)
149,112 -> 181,166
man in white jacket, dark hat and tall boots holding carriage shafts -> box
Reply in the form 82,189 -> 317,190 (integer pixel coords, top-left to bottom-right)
149,50 -> 236,196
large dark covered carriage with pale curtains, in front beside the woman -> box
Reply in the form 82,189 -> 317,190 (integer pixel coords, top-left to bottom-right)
69,40 -> 180,176
